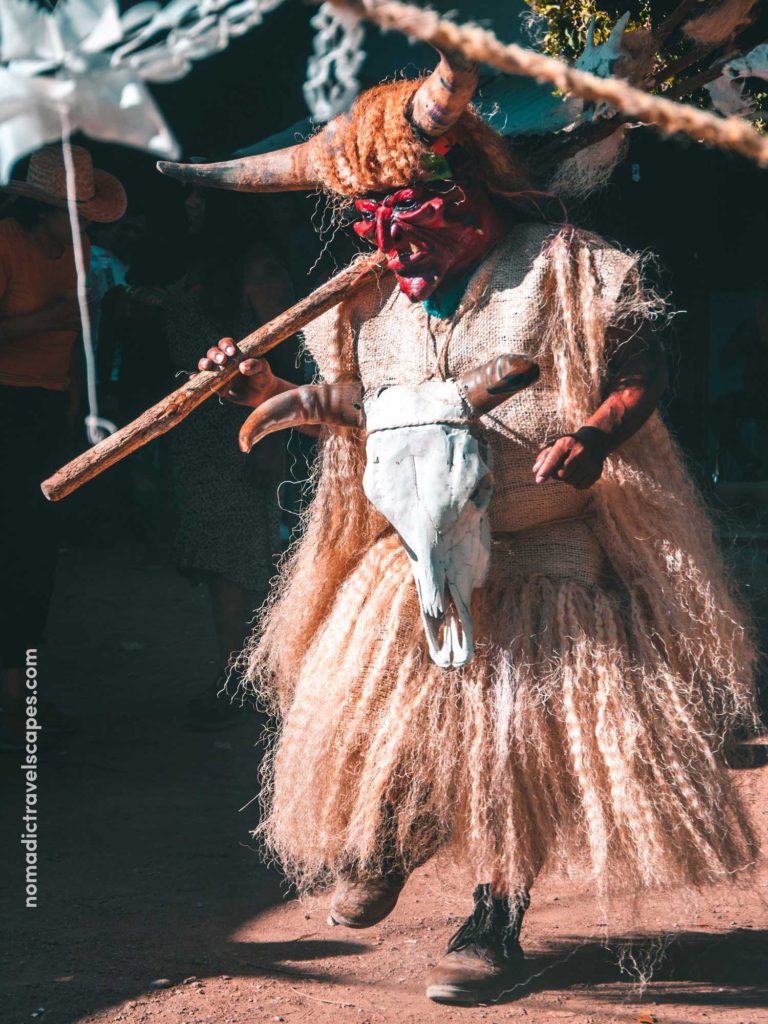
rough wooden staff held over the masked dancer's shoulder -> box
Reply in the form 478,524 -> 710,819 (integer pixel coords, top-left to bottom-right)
40,253 -> 384,502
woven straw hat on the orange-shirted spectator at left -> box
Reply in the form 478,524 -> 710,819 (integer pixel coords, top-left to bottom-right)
0,145 -> 127,223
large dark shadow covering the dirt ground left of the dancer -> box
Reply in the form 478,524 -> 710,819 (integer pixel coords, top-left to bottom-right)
0,546 -> 325,1024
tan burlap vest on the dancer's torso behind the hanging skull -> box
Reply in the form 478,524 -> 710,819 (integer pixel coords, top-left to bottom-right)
305,223 -> 633,534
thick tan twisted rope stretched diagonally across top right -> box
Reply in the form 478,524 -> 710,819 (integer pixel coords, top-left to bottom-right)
329,0 -> 768,167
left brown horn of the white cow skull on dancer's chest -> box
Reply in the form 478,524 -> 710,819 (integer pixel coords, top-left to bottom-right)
240,381 -> 365,452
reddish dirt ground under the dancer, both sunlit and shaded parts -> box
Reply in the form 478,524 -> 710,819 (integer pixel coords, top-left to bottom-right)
0,545 -> 768,1024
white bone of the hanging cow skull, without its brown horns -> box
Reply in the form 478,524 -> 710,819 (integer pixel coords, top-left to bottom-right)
362,381 -> 493,668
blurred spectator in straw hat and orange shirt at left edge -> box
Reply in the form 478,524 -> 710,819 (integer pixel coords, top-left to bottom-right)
0,145 -> 126,748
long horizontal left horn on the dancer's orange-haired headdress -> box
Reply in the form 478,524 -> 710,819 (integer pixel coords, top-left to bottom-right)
158,136 -> 321,191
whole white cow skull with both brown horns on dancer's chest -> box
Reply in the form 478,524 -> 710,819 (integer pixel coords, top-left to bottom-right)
241,355 -> 539,668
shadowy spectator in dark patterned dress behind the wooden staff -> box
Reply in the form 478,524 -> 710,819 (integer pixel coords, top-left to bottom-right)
164,188 -> 296,728
